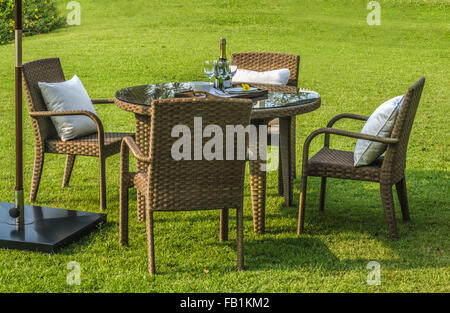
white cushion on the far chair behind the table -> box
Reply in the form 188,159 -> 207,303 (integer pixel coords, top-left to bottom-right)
232,68 -> 291,85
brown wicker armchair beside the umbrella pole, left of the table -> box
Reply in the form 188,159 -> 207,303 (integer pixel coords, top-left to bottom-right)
23,58 -> 134,209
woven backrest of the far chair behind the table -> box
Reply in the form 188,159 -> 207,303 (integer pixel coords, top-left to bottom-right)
231,52 -> 300,87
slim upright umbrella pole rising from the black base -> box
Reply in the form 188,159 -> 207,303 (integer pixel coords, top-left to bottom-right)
14,0 -> 24,225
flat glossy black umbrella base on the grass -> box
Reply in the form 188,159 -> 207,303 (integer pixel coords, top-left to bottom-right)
0,202 -> 106,253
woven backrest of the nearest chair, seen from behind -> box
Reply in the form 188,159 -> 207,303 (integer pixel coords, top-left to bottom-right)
148,98 -> 252,211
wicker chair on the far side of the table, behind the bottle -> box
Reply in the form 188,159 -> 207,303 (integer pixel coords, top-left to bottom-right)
231,52 -> 300,185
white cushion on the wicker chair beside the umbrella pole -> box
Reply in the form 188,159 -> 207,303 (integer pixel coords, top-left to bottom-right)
38,75 -> 97,141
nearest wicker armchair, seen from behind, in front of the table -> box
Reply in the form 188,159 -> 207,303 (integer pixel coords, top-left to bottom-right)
120,98 -> 252,275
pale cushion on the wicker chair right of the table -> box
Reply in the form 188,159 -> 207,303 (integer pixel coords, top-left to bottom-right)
354,96 -> 404,166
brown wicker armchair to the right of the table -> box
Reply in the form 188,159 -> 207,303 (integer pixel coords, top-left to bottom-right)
297,77 -> 425,239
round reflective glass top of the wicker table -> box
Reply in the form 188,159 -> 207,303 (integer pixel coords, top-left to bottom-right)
115,82 -> 320,109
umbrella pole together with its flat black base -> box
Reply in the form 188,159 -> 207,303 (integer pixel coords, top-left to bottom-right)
0,0 -> 106,253
